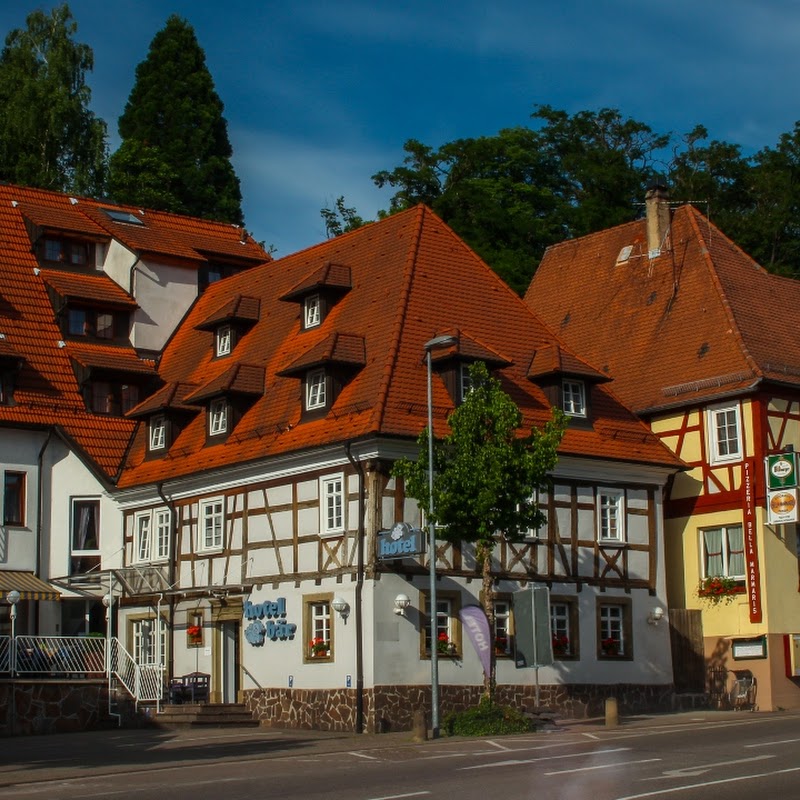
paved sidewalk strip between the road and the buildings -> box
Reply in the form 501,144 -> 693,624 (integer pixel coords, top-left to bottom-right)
0,711 -> 784,787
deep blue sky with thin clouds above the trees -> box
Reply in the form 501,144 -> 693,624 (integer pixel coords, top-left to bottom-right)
0,0 -> 800,256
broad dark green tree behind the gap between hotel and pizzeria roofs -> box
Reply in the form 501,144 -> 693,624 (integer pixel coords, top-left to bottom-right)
372,106 -> 669,293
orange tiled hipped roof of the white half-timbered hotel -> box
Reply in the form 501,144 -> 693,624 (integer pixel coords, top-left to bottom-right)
120,206 -> 679,486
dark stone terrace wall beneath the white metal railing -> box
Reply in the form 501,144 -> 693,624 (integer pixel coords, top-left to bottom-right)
0,680 -> 130,736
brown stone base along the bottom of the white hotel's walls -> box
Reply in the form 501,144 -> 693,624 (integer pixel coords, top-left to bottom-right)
242,684 -> 675,733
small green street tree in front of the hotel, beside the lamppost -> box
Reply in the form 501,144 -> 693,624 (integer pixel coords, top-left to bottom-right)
394,362 -> 566,696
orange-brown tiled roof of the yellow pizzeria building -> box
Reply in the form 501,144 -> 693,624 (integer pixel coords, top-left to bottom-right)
525,205 -> 800,413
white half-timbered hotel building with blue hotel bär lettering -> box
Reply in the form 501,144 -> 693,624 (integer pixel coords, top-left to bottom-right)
115,206 -> 683,730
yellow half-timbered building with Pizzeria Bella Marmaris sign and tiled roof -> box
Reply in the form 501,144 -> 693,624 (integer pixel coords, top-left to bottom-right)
525,188 -> 800,709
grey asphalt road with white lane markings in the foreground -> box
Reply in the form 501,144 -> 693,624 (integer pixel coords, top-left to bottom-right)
0,712 -> 800,800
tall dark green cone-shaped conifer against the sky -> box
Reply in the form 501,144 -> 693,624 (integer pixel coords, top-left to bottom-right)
109,15 -> 243,224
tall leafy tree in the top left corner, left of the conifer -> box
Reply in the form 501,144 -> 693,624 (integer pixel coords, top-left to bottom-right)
0,3 -> 107,196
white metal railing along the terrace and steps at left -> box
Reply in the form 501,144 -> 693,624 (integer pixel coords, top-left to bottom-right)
0,636 -> 164,703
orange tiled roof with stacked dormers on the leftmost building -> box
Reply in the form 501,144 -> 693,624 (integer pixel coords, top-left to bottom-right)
0,185 -> 266,481
